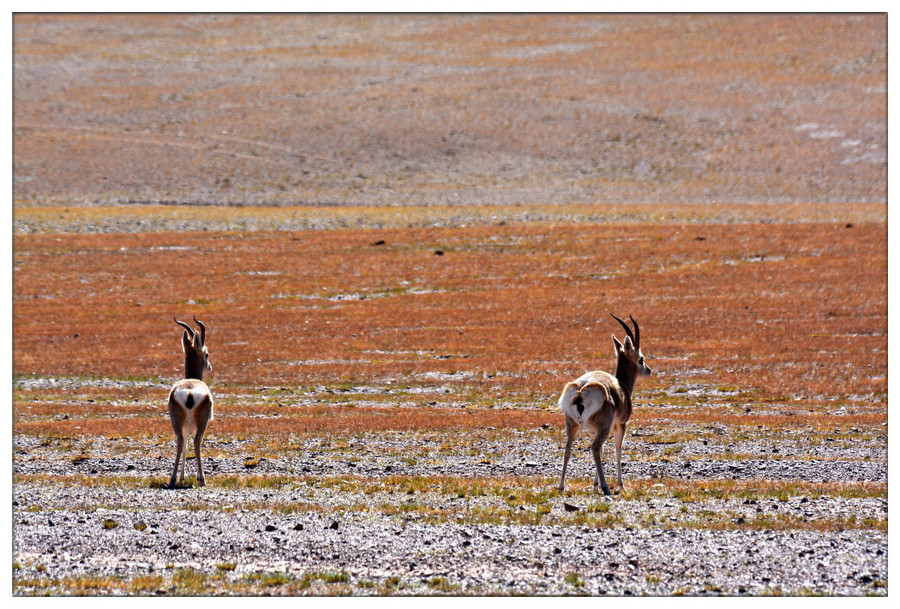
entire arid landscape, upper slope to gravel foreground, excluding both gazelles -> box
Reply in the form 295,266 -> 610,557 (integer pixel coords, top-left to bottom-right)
12,15 -> 888,596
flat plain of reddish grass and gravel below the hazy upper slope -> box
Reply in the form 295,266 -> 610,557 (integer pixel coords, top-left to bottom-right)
14,209 -> 887,594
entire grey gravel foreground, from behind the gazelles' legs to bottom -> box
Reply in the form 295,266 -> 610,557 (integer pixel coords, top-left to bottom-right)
13,422 -> 887,595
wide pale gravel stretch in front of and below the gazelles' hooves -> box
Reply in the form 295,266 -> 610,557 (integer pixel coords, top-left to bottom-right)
14,476 -> 887,595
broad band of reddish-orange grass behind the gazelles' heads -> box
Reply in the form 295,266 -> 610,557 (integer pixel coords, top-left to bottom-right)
13,224 -> 887,404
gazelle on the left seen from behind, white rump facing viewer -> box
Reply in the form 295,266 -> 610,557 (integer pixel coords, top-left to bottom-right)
169,317 -> 213,488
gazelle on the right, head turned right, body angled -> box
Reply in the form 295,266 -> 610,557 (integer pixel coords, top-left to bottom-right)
559,314 -> 650,495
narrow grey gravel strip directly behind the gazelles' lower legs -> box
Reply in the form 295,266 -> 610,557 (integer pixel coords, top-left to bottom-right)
14,433 -> 887,482
